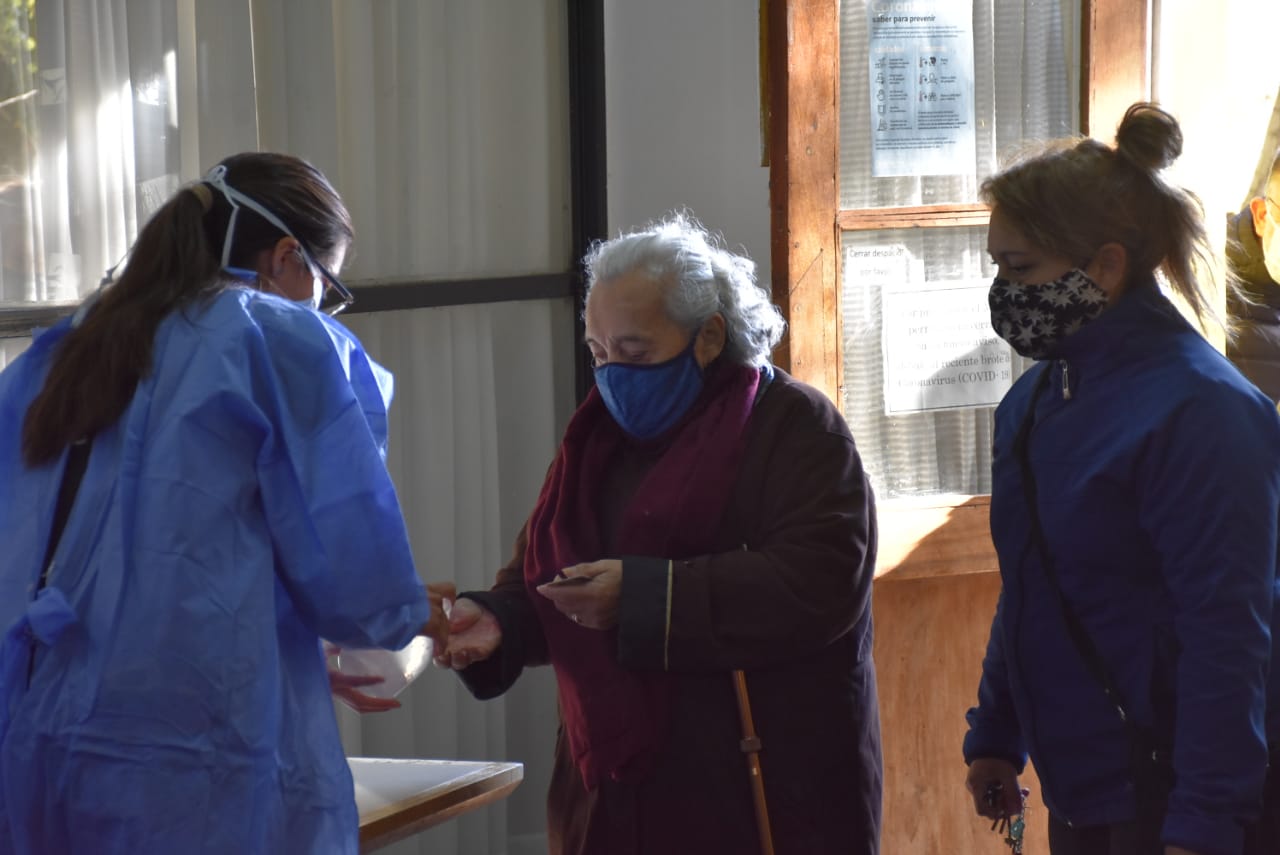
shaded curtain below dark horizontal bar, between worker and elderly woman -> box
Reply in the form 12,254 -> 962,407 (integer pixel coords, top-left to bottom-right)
339,300 -> 572,855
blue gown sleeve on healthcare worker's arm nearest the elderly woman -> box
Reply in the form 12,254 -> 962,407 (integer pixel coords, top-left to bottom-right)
248,301 -> 430,649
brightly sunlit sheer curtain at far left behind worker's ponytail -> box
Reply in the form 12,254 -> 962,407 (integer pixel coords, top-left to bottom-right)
0,0 -> 257,350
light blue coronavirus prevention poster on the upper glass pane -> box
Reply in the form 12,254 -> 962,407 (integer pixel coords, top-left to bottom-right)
867,0 -> 977,178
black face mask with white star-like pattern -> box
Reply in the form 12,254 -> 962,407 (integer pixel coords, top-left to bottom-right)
987,269 -> 1107,360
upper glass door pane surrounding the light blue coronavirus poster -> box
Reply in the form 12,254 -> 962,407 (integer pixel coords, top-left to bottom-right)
840,0 -> 1079,210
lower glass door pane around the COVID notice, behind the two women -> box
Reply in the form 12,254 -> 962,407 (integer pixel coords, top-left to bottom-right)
841,227 -> 1030,498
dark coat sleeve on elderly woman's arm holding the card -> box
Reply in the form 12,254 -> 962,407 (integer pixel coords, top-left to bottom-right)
618,390 -> 876,671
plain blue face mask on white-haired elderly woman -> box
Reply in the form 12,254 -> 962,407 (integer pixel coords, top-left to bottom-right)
595,335 -> 703,439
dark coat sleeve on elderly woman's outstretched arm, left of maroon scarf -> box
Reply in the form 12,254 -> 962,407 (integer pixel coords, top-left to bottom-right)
458,523 -> 549,700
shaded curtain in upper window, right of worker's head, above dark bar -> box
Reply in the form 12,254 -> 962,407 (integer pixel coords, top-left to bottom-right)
253,0 -> 571,280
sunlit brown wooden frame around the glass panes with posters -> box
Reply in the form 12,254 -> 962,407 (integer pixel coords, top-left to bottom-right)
760,0 -> 1152,576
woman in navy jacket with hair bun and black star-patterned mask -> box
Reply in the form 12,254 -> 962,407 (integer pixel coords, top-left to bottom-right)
964,104 -> 1280,855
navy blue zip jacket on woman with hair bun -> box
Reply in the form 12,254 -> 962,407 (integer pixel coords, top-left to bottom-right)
964,283 -> 1280,855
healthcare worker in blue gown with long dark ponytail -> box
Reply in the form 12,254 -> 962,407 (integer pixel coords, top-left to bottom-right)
0,154 -> 452,855
